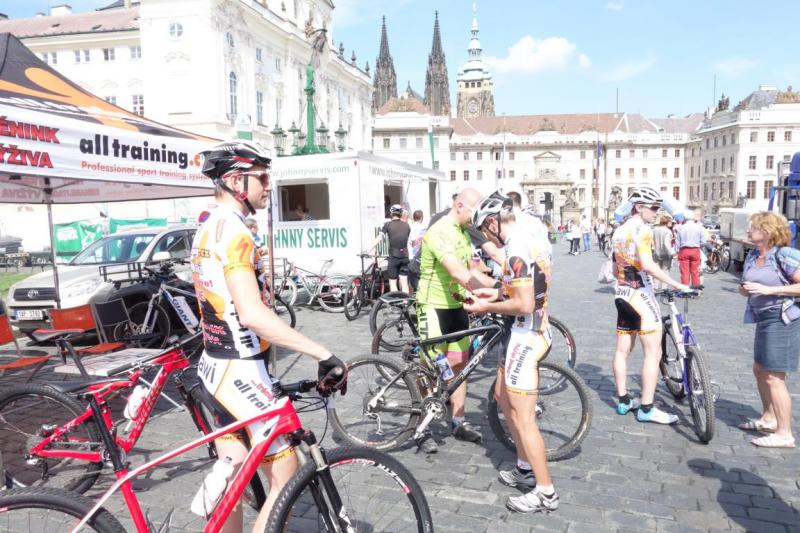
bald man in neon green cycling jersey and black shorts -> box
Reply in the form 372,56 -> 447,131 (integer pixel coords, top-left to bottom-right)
417,189 -> 494,453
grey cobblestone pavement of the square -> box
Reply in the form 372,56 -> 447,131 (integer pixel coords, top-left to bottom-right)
3,239 -> 800,532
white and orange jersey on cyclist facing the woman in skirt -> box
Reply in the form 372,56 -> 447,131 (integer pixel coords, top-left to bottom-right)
611,217 -> 653,289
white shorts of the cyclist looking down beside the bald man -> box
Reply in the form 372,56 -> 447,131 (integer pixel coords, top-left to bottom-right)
500,326 -> 553,396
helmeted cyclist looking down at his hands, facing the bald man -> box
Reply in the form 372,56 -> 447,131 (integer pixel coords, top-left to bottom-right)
464,193 -> 558,513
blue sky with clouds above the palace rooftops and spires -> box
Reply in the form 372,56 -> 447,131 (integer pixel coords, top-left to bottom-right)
0,0 -> 800,117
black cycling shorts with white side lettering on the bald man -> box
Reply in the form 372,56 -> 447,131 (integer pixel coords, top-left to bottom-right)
417,304 -> 470,366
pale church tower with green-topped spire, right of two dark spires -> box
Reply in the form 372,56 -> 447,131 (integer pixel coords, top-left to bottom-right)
456,2 -> 494,118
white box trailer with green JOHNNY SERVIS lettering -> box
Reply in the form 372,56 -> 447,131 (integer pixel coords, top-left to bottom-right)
256,152 -> 451,274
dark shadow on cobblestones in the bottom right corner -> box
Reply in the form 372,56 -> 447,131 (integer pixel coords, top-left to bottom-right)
686,459 -> 800,531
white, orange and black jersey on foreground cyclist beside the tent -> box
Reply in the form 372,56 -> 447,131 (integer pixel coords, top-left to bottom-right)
192,205 -> 269,359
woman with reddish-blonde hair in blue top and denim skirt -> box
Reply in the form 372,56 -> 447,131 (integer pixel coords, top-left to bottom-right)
739,212 -> 800,448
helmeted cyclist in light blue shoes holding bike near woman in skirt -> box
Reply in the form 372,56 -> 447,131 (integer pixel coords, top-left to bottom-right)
611,187 -> 689,424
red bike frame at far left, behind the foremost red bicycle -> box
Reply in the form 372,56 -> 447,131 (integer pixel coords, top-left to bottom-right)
30,350 -> 205,462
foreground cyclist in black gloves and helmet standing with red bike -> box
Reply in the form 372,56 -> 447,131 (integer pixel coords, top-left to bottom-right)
192,141 -> 347,531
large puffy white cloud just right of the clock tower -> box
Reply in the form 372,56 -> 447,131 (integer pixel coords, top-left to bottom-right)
486,35 -> 592,74
